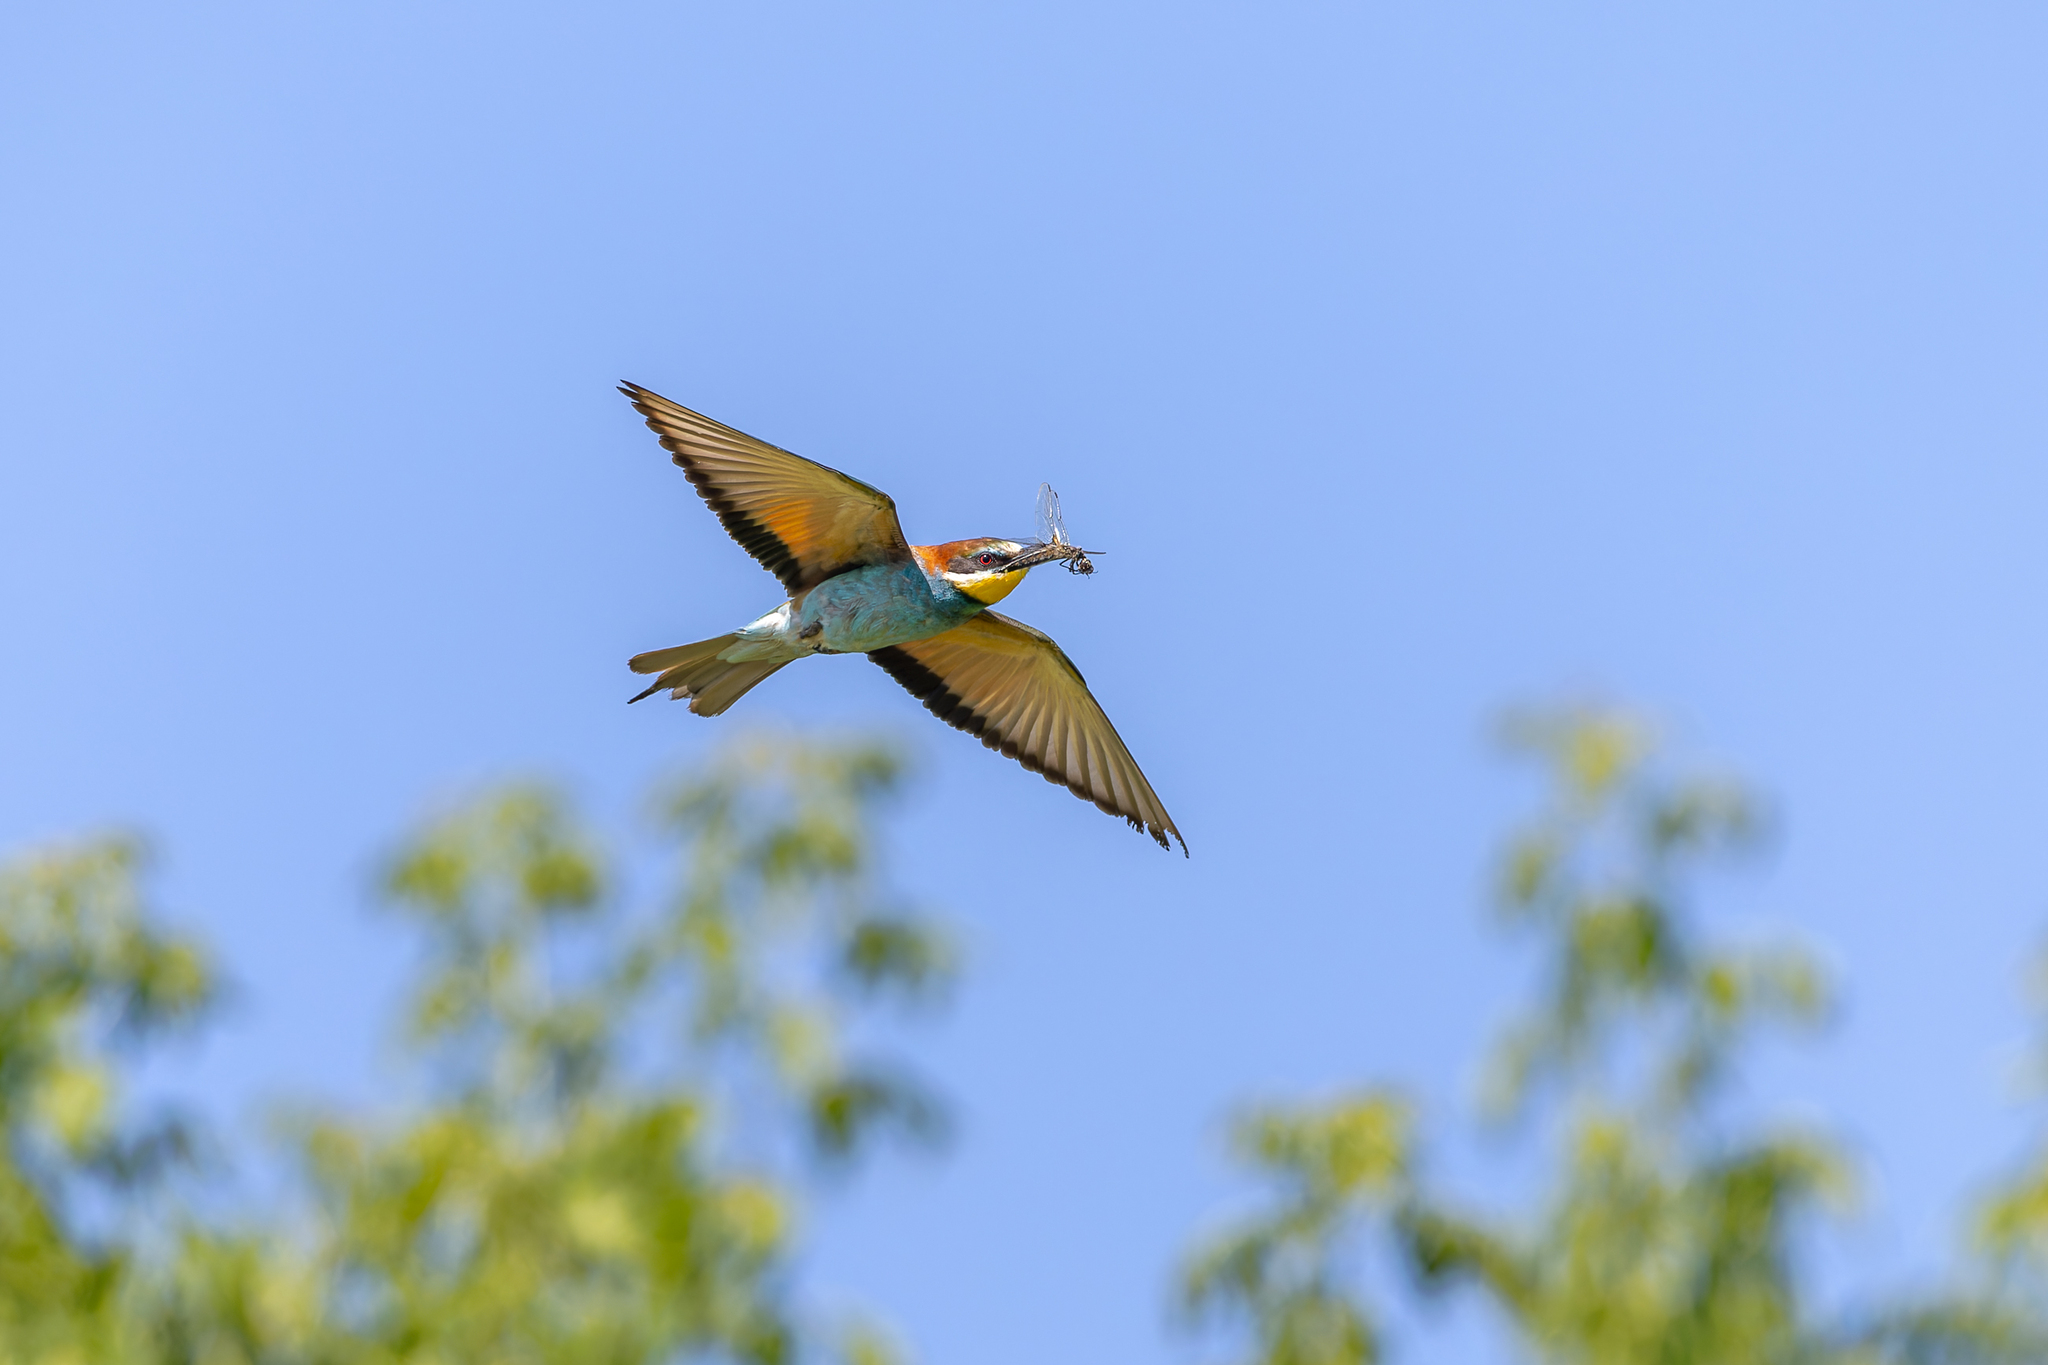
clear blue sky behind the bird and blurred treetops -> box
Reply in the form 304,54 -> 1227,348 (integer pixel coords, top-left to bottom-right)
0,0 -> 2048,1365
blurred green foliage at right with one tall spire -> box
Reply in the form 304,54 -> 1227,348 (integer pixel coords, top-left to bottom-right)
1180,710 -> 2048,1365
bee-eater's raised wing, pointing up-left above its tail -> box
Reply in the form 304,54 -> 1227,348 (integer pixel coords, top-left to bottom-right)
618,385 -> 909,598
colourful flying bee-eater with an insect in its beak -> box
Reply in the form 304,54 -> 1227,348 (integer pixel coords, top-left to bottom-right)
618,385 -> 1188,853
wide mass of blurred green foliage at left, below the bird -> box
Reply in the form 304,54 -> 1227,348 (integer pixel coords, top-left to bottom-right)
0,743 -> 950,1365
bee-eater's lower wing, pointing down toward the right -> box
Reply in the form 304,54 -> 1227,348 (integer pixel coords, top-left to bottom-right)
868,612 -> 1188,853
